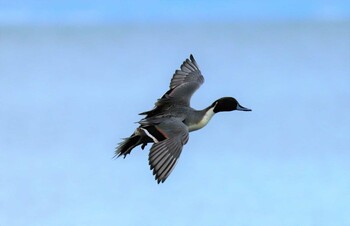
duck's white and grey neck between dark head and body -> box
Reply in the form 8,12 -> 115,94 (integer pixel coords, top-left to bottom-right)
185,105 -> 215,132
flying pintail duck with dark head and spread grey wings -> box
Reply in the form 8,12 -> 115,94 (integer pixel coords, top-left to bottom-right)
115,55 -> 251,183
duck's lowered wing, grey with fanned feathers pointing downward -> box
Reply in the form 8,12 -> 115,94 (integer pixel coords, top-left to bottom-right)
148,119 -> 188,183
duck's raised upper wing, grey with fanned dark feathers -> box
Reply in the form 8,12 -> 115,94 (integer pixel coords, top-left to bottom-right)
163,54 -> 204,106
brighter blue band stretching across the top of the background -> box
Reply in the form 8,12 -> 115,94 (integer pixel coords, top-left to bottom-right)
0,0 -> 350,23
